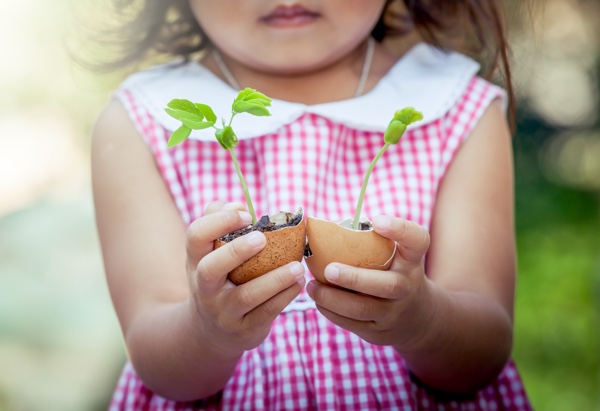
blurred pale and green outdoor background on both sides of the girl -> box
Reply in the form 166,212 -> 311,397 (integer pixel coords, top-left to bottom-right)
0,0 -> 600,411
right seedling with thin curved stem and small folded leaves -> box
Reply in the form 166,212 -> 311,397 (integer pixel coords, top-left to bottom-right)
352,107 -> 423,230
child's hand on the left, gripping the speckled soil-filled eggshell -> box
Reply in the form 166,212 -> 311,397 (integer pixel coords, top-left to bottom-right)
187,202 -> 305,356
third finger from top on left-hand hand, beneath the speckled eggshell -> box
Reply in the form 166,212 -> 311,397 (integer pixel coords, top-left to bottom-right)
231,261 -> 304,317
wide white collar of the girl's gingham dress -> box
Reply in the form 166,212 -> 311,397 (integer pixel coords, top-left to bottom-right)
122,43 -> 479,141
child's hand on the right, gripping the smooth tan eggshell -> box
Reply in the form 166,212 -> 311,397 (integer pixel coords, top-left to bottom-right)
307,216 -> 434,350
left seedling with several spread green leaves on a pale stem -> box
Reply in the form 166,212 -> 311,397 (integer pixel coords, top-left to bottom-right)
165,88 -> 271,225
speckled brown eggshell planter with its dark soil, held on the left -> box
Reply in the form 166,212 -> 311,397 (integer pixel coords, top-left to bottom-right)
215,209 -> 306,285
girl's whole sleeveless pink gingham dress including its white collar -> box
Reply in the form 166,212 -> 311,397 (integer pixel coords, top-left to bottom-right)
110,44 -> 531,411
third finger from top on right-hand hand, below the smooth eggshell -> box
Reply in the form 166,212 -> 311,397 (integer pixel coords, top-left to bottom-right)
306,281 -> 386,321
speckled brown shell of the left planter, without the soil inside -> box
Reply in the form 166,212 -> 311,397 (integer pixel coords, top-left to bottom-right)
215,210 -> 306,285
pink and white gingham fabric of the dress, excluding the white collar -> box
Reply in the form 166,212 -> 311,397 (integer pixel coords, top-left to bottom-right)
110,77 -> 531,411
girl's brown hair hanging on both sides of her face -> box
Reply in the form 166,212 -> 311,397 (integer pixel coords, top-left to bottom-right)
83,0 -> 514,120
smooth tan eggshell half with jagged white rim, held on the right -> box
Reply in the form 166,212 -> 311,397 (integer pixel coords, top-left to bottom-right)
305,217 -> 396,284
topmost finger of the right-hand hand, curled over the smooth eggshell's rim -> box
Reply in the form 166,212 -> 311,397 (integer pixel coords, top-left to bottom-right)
373,216 -> 430,262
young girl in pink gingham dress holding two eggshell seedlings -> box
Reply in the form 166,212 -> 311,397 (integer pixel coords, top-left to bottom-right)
92,0 -> 530,411
